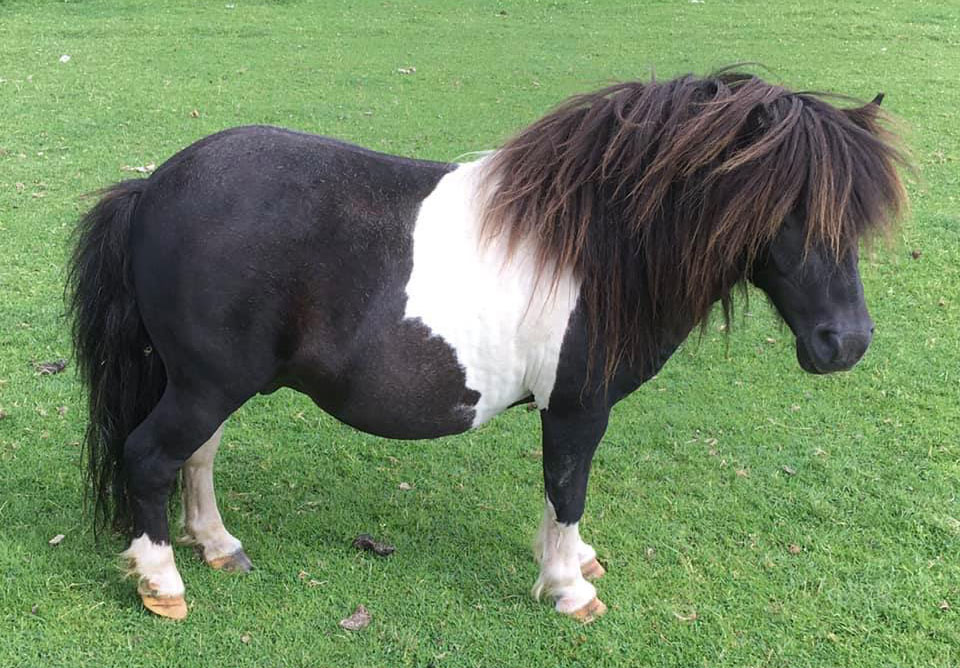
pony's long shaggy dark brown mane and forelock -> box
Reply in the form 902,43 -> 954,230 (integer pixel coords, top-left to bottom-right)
481,71 -> 906,380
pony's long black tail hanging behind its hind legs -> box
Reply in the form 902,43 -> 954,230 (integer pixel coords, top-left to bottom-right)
67,180 -> 166,534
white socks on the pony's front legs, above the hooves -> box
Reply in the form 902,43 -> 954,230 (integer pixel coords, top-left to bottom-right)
533,500 -> 597,614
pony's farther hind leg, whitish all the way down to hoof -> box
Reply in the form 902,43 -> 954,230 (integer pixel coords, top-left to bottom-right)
178,424 -> 253,572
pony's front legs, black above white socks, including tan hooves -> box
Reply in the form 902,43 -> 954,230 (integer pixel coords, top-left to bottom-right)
533,410 -> 608,622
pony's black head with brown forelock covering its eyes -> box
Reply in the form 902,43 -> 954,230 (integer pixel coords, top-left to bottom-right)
750,93 -> 904,374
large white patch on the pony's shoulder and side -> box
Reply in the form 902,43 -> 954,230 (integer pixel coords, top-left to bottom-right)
404,160 -> 580,426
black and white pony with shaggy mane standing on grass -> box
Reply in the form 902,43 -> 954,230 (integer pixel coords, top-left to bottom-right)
69,72 -> 905,620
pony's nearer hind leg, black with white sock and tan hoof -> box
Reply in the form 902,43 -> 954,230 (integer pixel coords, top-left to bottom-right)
123,384 -> 236,619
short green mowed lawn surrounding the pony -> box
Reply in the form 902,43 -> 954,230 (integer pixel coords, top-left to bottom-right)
0,0 -> 960,668
